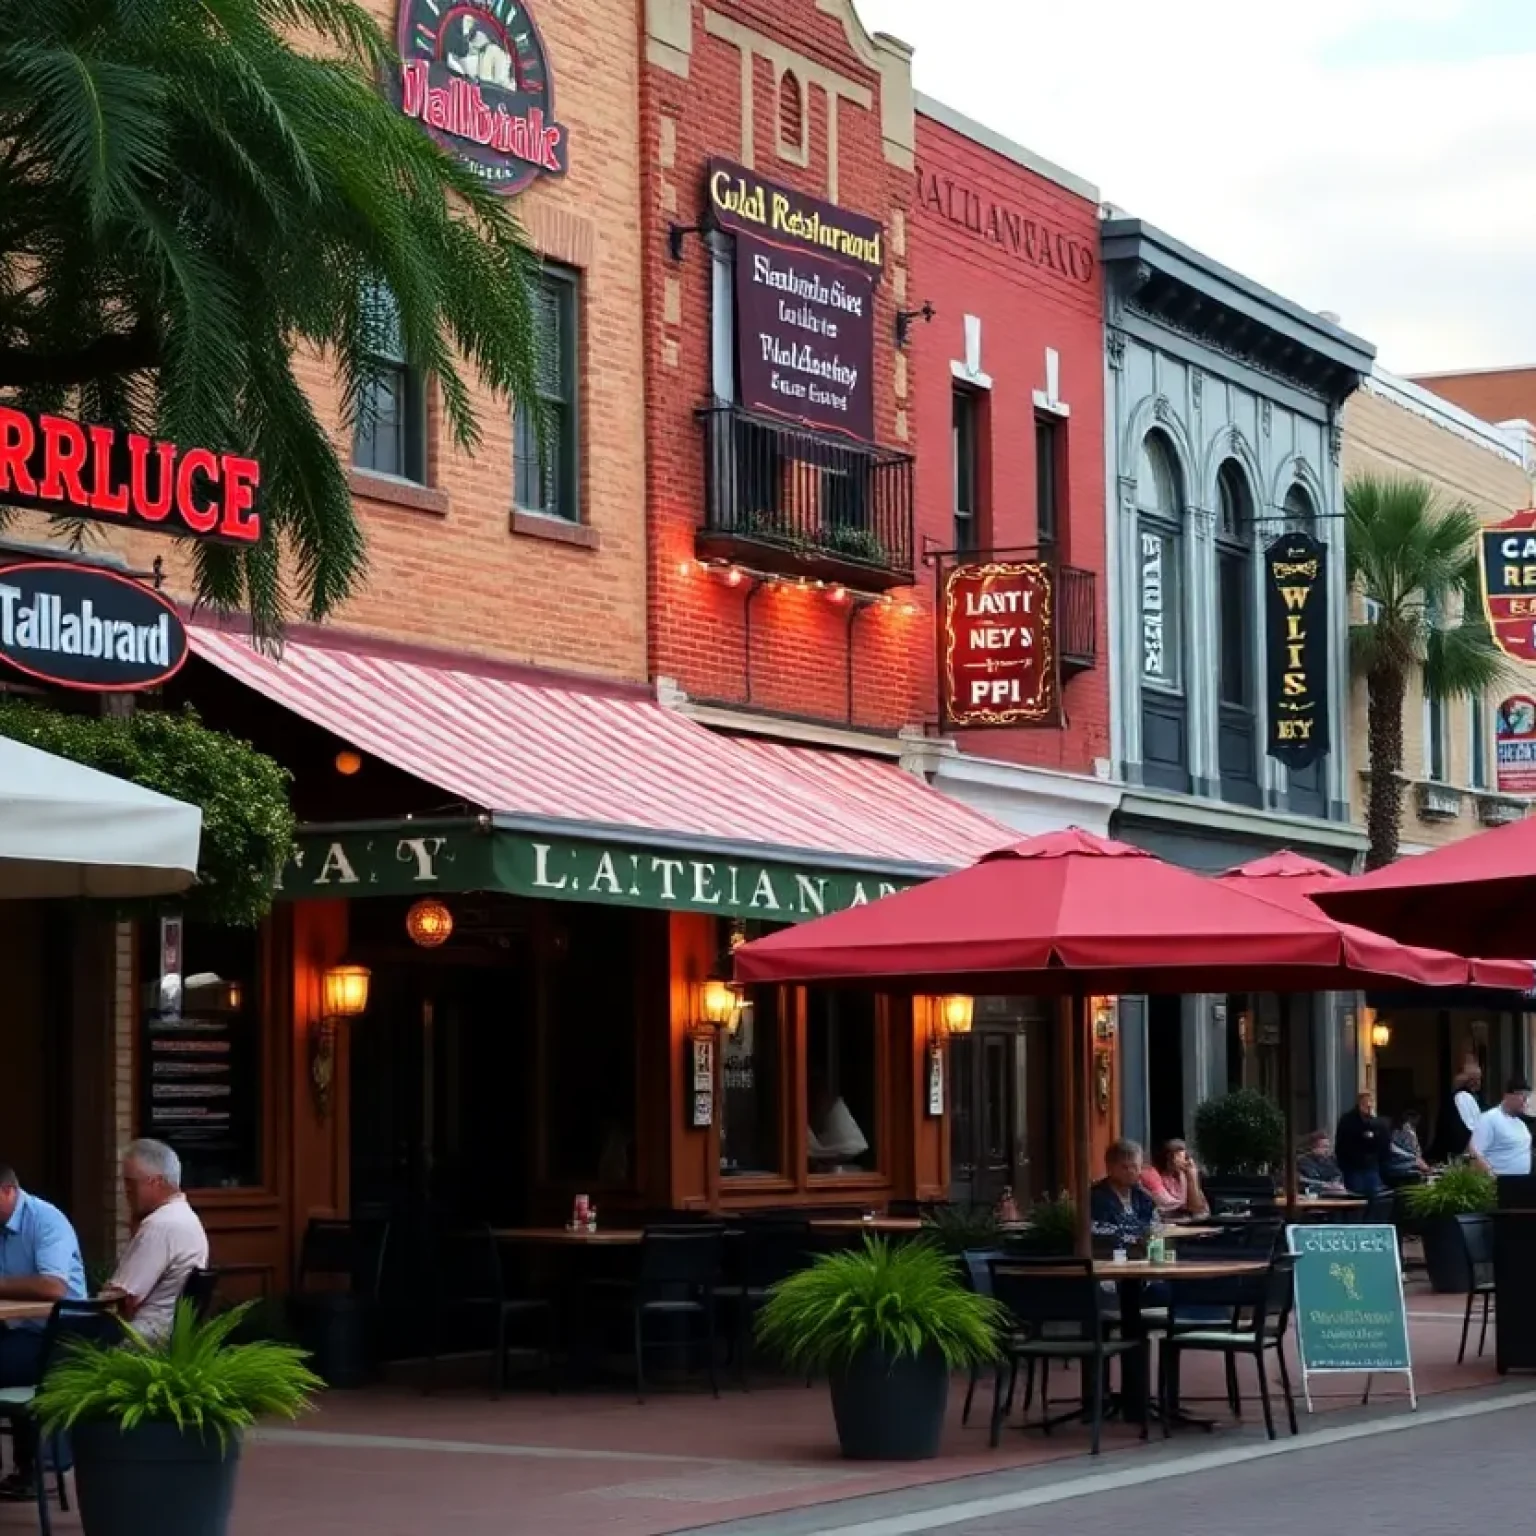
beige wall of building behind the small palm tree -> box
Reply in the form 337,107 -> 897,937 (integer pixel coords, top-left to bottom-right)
1342,384 -> 1536,846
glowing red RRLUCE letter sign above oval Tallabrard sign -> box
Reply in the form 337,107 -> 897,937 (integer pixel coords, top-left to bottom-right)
0,406 -> 261,544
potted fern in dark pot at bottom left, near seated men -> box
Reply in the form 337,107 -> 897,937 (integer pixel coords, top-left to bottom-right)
34,1303 -> 321,1536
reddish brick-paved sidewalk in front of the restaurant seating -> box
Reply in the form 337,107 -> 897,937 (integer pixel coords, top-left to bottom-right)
0,1292 -> 1498,1536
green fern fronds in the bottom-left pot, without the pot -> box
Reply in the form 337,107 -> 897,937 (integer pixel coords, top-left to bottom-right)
32,1301 -> 321,1444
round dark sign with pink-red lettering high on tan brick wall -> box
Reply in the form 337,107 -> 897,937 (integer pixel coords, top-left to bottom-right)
392,0 -> 568,197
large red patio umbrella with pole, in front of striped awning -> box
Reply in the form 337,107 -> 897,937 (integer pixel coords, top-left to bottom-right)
736,826 -> 1462,1250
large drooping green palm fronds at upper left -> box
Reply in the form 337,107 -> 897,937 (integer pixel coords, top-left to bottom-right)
0,0 -> 536,633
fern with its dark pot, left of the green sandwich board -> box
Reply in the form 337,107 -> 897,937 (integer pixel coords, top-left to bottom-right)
757,1236 -> 1005,1461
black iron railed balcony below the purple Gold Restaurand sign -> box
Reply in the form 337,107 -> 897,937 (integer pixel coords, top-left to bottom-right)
696,406 -> 914,591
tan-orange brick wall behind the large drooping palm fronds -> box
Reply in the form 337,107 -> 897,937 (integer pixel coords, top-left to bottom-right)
12,0 -> 645,679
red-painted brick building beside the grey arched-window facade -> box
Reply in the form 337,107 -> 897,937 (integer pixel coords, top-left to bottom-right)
911,97 -> 1109,825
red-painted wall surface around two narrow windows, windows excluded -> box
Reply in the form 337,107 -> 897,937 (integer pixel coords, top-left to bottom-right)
911,112 -> 1109,773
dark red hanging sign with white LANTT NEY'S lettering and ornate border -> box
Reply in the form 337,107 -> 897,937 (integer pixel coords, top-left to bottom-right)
940,561 -> 1058,727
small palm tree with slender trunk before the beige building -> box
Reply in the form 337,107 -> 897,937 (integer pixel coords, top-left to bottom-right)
1344,475 -> 1508,869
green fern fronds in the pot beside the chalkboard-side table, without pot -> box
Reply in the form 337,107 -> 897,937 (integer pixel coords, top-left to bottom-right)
756,1235 -> 1006,1370
